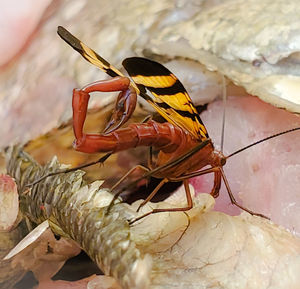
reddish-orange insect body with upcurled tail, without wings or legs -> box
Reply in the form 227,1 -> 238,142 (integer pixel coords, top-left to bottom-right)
72,78 -> 221,179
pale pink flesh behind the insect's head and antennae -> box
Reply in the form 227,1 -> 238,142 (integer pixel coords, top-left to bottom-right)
191,97 -> 300,235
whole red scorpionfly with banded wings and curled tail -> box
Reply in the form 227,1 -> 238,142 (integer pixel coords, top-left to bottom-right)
52,26 -> 300,217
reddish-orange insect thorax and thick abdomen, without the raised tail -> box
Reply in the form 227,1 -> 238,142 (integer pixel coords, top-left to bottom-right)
74,115 -> 220,178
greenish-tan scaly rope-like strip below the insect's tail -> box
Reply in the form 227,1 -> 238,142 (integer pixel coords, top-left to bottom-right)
6,146 -> 151,289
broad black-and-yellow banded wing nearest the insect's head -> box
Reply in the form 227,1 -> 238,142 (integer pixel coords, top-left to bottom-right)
123,57 -> 208,140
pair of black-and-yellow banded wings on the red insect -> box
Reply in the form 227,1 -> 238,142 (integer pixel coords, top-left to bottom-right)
57,26 -> 208,140
